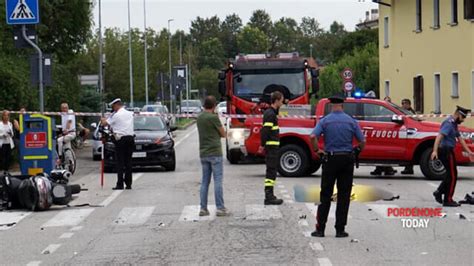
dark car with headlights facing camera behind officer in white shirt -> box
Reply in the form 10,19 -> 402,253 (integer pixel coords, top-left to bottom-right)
104,112 -> 177,172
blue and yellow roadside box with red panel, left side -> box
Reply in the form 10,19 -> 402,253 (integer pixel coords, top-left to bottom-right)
19,112 -> 56,176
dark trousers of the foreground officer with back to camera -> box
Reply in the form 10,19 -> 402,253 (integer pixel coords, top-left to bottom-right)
316,153 -> 354,231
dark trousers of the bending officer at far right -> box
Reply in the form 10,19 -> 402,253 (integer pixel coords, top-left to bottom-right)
438,147 -> 458,202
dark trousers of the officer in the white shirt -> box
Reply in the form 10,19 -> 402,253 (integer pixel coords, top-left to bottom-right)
115,136 -> 135,188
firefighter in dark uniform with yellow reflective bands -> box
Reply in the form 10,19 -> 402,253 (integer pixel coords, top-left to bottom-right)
259,91 -> 284,205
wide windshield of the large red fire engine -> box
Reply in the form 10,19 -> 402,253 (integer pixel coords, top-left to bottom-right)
234,69 -> 306,99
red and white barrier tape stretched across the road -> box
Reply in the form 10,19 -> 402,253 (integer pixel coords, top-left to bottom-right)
10,111 -> 474,119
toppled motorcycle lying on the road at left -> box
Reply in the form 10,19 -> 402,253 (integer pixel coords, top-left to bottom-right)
0,170 -> 81,211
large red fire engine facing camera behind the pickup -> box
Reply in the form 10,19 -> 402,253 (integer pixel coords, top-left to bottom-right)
219,52 -> 319,163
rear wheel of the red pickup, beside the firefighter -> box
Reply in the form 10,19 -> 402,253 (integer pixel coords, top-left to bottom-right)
278,144 -> 309,177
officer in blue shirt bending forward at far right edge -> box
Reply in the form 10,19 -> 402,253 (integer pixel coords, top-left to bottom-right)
431,106 -> 474,207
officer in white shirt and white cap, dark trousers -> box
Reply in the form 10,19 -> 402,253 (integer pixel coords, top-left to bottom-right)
101,98 -> 135,190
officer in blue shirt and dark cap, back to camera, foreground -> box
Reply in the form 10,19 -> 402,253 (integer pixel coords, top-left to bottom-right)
311,96 -> 365,237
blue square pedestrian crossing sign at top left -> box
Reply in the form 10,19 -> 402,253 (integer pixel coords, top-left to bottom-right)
5,0 -> 39,25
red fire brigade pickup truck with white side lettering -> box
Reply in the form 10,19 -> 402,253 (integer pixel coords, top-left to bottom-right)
243,98 -> 474,179
